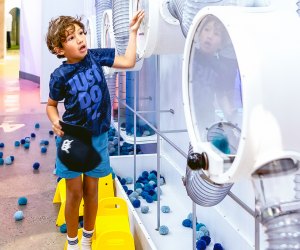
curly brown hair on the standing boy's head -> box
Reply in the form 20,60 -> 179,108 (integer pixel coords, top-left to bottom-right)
46,16 -> 86,58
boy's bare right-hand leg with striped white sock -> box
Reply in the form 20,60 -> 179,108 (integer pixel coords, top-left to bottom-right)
81,175 -> 99,250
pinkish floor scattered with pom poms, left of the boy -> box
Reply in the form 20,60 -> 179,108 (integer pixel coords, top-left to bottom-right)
0,51 -> 66,250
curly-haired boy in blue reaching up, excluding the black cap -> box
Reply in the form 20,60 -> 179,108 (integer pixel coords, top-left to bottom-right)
46,11 -> 144,250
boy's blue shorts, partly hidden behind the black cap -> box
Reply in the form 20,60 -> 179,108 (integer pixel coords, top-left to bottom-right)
55,132 -> 112,179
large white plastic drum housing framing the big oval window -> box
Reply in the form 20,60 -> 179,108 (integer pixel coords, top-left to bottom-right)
182,6 -> 300,183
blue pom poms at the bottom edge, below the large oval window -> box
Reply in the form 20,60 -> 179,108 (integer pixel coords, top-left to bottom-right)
182,213 -> 223,250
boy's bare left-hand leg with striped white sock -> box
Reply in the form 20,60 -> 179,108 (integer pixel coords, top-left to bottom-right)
65,176 -> 83,250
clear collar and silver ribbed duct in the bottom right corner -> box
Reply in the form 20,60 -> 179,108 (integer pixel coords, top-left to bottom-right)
252,159 -> 300,250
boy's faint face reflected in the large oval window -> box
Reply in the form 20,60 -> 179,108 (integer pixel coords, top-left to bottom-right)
200,21 -> 222,54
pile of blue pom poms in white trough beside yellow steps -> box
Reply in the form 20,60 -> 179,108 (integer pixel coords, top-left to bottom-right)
118,170 -> 165,208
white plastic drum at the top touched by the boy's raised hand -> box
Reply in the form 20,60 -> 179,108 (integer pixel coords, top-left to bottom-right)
129,0 -> 185,58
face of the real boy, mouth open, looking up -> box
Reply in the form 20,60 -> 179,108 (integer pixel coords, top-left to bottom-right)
60,24 -> 87,63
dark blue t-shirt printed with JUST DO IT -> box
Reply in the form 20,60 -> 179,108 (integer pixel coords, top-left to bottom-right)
49,49 -> 115,135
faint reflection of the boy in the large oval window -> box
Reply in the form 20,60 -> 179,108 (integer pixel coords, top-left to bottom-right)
192,15 -> 238,126
